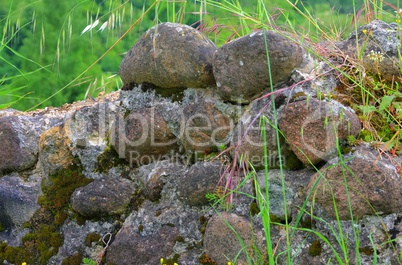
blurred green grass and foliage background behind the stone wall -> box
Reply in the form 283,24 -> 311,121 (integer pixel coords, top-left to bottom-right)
0,0 -> 399,110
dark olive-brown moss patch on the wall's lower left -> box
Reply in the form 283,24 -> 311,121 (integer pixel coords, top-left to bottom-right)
0,162 -> 92,265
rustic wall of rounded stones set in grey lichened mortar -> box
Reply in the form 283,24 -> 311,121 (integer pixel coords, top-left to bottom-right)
0,21 -> 402,265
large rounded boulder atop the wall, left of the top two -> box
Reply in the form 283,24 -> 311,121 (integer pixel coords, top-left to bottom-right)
120,22 -> 216,91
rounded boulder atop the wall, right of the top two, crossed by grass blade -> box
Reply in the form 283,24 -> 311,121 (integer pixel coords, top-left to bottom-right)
212,31 -> 303,103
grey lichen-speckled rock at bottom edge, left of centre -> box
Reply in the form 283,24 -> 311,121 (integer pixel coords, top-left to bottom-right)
106,198 -> 203,265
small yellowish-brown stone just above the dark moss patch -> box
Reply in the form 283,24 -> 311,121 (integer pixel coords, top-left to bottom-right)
39,126 -> 73,175
